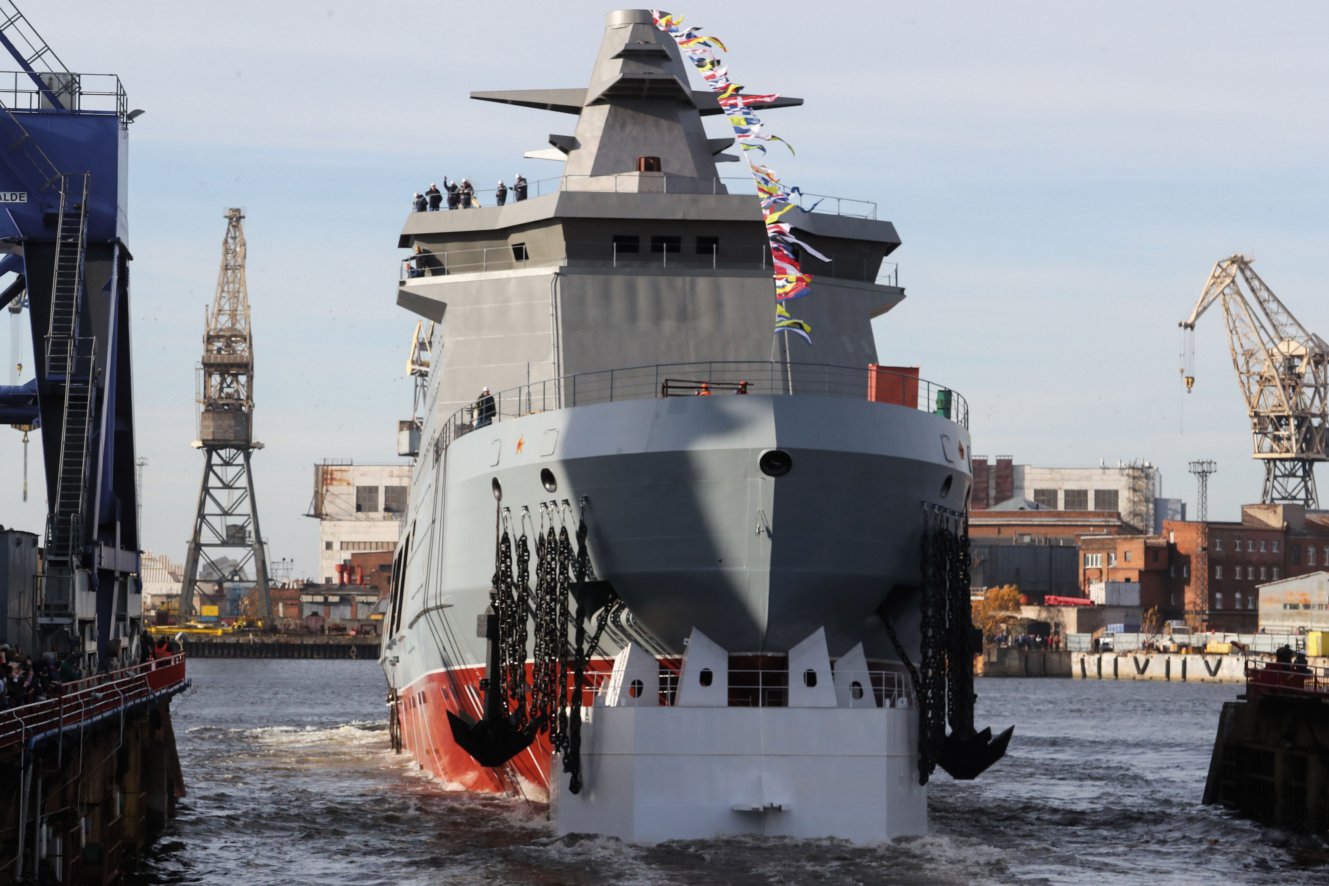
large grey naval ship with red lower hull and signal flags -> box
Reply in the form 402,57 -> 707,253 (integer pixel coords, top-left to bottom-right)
381,11 -> 1009,842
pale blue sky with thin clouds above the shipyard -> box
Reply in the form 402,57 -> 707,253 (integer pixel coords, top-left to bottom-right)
0,0 -> 1329,574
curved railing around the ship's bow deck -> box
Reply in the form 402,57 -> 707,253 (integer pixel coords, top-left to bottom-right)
429,361 -> 969,458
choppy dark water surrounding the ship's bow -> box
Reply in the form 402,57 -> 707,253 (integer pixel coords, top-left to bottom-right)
133,659 -> 1329,886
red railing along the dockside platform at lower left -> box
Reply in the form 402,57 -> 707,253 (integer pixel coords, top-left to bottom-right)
0,655 -> 189,751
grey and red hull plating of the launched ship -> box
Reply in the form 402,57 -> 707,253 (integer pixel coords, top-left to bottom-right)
384,396 -> 969,834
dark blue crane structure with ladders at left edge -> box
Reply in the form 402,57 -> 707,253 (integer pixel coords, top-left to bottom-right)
0,0 -> 142,667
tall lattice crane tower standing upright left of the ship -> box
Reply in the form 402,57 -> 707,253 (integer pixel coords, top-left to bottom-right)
179,209 -> 272,623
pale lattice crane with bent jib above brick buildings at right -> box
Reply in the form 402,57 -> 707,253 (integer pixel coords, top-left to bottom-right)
1181,255 -> 1329,509
